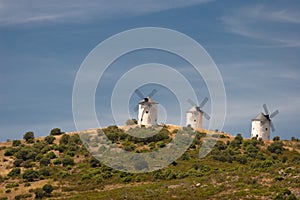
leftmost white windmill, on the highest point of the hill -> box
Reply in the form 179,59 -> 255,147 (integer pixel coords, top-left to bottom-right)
135,89 -> 158,126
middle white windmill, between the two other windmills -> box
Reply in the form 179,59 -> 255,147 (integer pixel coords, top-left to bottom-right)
186,97 -> 210,129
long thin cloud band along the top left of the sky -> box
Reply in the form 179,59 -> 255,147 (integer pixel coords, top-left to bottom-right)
0,0 -> 211,25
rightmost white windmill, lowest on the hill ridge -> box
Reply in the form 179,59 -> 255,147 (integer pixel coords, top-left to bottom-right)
251,104 -> 279,140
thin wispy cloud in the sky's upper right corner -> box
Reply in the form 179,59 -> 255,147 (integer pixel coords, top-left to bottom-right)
221,5 -> 300,47
